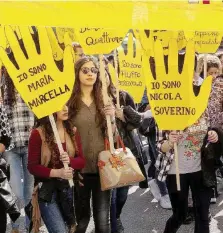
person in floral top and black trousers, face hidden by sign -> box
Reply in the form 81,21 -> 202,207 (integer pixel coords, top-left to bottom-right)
157,121 -> 222,233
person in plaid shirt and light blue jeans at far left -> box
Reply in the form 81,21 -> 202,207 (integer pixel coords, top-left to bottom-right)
2,65 -> 34,233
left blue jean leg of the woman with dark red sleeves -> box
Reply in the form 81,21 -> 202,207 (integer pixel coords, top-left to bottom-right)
39,193 -> 67,233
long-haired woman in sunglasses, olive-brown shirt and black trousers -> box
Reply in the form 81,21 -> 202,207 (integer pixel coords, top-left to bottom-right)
68,57 -> 115,233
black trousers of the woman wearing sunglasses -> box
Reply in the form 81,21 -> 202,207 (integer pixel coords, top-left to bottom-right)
76,174 -> 111,233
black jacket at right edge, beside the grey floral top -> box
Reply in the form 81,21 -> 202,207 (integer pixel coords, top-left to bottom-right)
201,128 -> 223,187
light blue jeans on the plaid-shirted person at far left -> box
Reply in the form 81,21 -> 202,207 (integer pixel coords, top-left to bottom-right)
3,147 -> 34,229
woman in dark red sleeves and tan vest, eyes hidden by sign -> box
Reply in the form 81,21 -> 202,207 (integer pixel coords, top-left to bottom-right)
28,106 -> 85,233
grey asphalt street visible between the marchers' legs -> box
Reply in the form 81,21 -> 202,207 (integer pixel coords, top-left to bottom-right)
7,182 -> 223,233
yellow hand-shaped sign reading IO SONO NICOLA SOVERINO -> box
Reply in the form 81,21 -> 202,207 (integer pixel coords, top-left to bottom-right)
143,39 -> 212,130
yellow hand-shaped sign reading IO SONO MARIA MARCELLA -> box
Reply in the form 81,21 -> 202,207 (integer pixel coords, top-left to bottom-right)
0,26 -> 75,118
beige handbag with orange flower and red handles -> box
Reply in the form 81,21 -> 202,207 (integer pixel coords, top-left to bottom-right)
98,136 -> 145,191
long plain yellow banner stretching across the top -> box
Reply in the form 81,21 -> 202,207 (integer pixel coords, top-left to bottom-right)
0,0 -> 223,31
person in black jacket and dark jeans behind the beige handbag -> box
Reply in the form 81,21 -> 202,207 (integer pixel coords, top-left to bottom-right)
104,59 -> 148,233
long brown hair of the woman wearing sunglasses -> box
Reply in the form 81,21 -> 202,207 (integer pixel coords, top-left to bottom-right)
68,56 -> 106,131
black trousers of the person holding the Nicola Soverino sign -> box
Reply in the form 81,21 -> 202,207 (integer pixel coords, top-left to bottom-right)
164,171 -> 212,233
